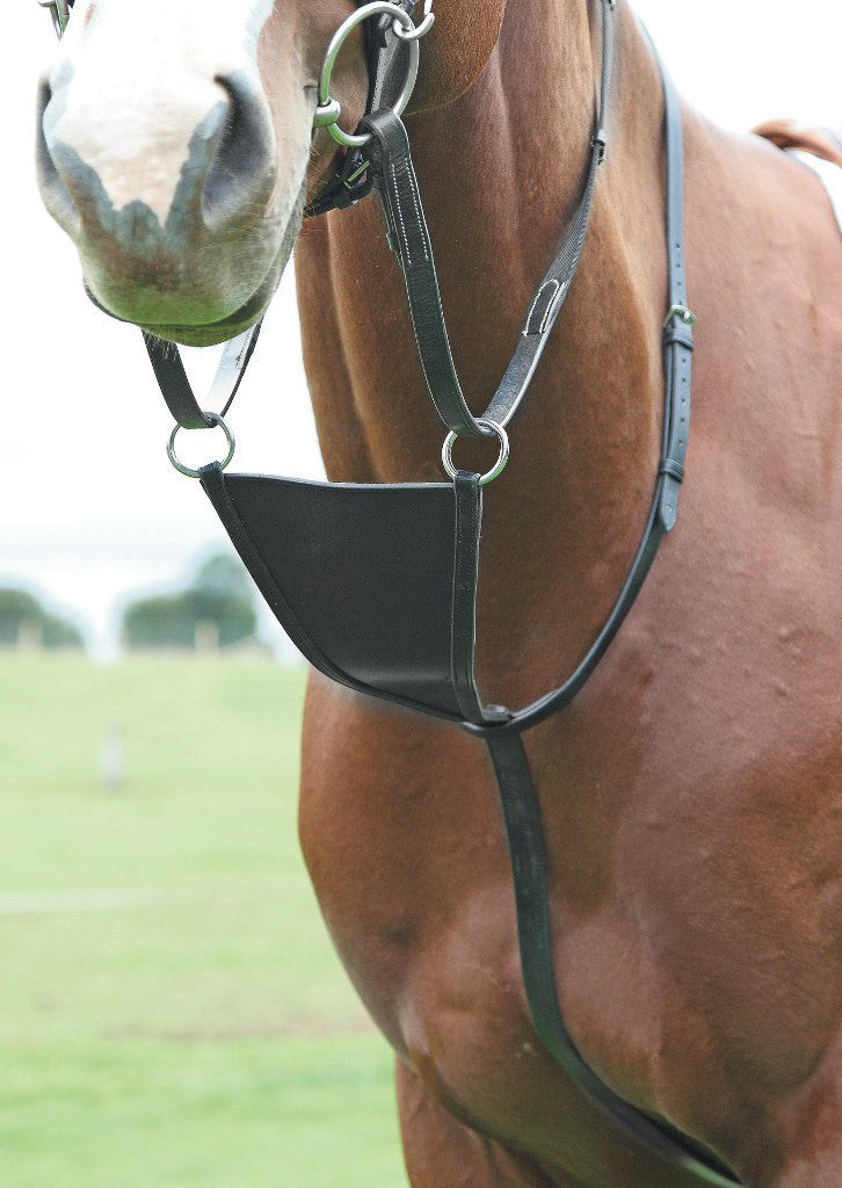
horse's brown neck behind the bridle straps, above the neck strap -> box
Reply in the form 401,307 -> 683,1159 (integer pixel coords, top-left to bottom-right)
299,0 -> 665,697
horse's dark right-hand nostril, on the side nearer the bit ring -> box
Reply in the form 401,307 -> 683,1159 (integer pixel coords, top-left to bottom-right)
202,71 -> 274,226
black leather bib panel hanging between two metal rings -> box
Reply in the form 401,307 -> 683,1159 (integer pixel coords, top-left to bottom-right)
202,466 -> 479,721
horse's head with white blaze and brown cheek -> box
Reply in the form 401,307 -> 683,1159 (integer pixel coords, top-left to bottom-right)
38,0 -> 505,345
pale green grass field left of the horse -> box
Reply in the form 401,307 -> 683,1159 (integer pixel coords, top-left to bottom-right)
0,653 -> 406,1188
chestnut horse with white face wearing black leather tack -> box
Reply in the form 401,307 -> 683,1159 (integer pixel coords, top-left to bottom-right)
39,0 -> 842,1188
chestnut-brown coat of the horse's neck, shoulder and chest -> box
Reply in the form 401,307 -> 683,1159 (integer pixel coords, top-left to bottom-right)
297,4 -> 842,1188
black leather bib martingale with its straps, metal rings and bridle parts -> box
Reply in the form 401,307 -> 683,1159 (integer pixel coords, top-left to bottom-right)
38,0 -> 740,1188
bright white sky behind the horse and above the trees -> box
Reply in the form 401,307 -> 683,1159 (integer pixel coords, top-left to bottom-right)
0,0 -> 842,652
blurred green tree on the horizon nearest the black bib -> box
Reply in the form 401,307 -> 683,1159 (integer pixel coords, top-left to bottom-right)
121,554 -> 258,649
